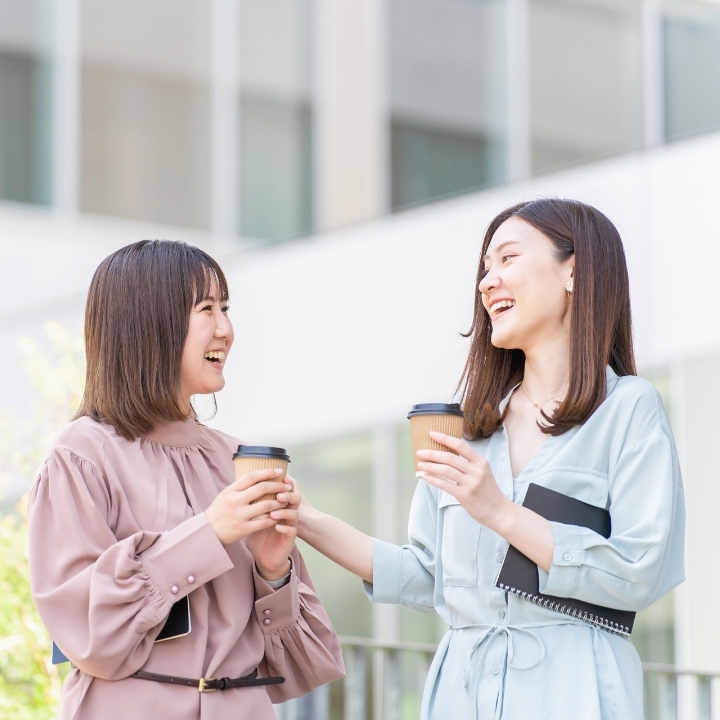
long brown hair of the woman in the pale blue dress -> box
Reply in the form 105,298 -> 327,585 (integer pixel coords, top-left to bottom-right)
458,199 -> 636,440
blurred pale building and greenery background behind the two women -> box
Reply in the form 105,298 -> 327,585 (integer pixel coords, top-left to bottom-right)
0,0 -> 720,720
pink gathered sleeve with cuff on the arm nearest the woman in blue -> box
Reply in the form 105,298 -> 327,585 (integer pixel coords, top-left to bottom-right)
253,548 -> 345,703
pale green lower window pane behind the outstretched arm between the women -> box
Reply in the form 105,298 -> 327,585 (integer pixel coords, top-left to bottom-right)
290,434 -> 372,637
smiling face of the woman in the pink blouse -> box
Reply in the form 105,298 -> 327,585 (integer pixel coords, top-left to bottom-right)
180,280 -> 234,404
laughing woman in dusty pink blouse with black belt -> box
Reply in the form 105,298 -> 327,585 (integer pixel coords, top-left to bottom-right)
29,241 -> 344,720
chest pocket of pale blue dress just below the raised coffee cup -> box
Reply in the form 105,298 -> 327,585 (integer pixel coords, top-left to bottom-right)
438,492 -> 482,587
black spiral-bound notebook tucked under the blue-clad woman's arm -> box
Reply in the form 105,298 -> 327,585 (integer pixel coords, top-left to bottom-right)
495,483 -> 635,635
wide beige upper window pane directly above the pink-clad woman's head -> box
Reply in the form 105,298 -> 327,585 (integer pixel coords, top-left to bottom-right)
81,0 -> 211,228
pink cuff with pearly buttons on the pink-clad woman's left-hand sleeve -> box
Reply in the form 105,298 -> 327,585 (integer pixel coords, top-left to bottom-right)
140,514 -> 234,603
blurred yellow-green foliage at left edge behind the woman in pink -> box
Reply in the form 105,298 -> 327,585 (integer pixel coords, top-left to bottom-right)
0,323 -> 84,720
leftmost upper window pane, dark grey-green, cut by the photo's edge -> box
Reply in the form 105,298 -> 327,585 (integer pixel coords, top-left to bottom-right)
0,0 -> 52,205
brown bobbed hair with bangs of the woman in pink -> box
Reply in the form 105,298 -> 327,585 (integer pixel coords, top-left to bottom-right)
73,240 -> 229,440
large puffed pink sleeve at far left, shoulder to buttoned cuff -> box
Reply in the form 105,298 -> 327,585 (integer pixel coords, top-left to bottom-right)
28,447 -> 233,680
